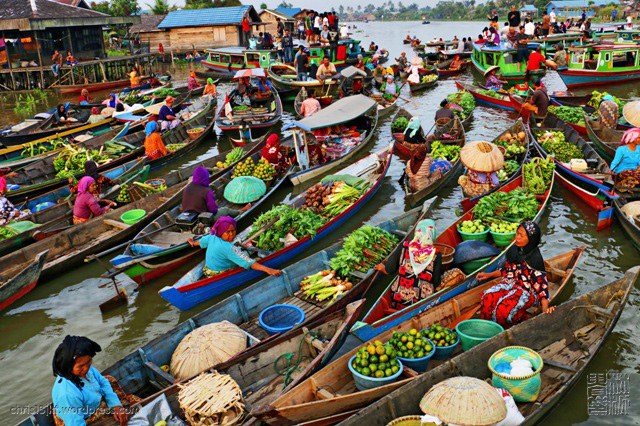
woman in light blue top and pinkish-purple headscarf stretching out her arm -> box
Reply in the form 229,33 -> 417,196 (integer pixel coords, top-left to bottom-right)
187,216 -> 280,277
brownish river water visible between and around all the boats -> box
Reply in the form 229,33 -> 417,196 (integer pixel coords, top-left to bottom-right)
0,22 -> 640,425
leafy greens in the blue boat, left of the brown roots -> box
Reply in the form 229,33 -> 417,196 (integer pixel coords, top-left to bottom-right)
245,205 -> 327,251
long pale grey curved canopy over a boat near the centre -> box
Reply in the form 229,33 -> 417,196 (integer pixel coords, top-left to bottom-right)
283,95 -> 378,132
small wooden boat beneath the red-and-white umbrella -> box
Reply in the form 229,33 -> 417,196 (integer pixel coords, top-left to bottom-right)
215,88 -> 282,132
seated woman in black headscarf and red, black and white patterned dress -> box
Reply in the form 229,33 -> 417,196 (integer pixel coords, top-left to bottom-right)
477,222 -> 555,327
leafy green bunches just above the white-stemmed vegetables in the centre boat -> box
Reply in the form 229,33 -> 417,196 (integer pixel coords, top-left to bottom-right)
331,225 -> 398,278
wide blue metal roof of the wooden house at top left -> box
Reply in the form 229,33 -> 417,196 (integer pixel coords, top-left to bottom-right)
158,6 -> 252,28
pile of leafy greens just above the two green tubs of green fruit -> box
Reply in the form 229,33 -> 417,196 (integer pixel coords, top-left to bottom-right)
473,188 -> 538,223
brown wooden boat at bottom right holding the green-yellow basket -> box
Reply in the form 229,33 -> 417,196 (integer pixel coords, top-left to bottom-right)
336,266 -> 640,425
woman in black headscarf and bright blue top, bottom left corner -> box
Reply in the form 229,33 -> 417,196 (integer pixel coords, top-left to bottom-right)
51,336 -> 140,426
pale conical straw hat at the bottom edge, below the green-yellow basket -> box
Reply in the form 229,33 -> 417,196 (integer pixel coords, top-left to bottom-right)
420,377 -> 507,426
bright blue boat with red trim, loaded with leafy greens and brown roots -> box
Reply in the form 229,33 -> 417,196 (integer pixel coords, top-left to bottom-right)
159,145 -> 393,311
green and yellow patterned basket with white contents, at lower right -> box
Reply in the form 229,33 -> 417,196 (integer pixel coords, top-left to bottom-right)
488,346 -> 544,402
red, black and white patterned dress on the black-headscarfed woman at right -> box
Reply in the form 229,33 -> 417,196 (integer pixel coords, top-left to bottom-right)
480,262 -> 549,326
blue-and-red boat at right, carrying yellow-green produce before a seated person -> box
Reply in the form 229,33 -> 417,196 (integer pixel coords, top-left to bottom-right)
527,115 -> 617,212
